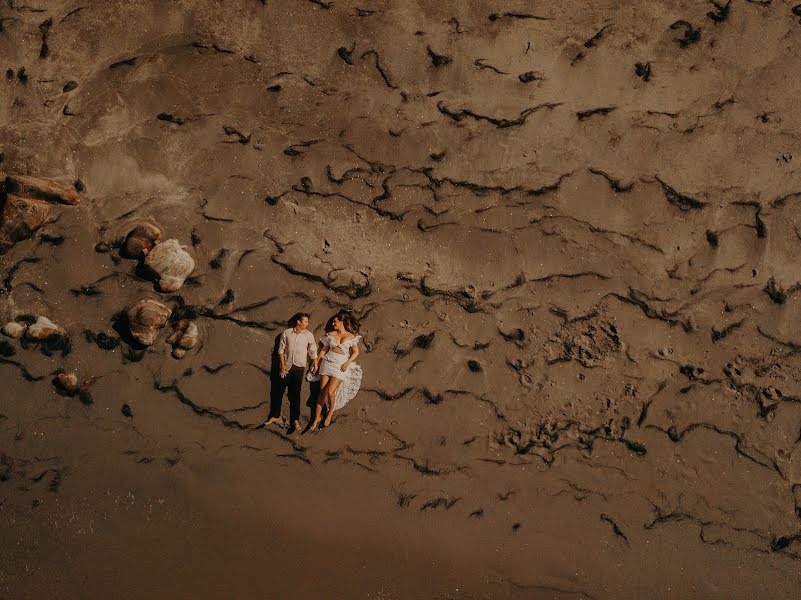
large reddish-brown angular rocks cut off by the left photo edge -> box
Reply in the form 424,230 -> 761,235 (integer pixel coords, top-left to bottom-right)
0,175 -> 82,254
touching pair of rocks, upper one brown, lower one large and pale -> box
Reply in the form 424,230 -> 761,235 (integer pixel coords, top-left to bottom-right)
120,221 -> 195,292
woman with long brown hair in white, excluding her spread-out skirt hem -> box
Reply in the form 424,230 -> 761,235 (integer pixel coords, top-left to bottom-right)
308,313 -> 362,431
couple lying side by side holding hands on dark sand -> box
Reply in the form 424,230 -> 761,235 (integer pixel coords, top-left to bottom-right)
264,312 -> 361,433
